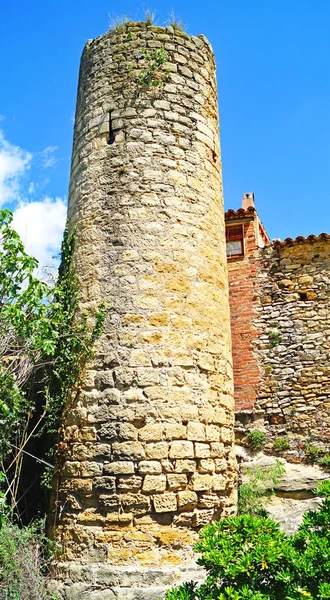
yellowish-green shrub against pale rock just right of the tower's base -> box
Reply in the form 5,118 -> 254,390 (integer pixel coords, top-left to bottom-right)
238,460 -> 285,516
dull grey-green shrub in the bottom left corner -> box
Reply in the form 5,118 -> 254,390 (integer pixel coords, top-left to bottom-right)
0,519 -> 51,600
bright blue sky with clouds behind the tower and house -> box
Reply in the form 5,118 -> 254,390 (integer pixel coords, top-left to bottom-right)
0,0 -> 330,262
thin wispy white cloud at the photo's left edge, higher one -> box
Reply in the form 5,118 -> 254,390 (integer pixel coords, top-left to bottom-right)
0,131 -> 32,206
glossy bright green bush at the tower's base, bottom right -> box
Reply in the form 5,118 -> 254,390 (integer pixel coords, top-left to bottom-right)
166,481 -> 330,600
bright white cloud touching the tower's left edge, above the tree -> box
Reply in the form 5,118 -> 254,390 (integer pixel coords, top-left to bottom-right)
13,197 -> 66,268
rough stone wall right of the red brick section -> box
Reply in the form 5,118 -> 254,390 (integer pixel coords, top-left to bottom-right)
237,234 -> 330,462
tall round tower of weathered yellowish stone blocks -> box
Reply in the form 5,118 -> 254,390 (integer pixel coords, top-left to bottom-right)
49,23 -> 236,600
